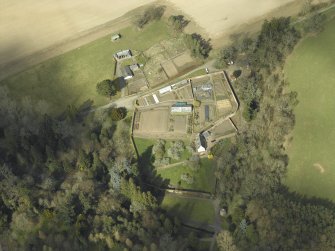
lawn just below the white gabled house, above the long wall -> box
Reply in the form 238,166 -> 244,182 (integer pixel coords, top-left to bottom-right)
157,159 -> 215,193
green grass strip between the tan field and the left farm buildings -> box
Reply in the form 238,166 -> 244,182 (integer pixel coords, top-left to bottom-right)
0,21 -> 170,114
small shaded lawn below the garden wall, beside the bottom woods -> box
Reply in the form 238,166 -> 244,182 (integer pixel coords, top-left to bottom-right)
162,194 -> 215,224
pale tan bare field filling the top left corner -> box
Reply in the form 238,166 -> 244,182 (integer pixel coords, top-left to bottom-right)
0,0 -> 154,65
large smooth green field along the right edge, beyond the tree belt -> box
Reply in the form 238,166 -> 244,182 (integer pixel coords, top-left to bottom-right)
285,20 -> 335,201
